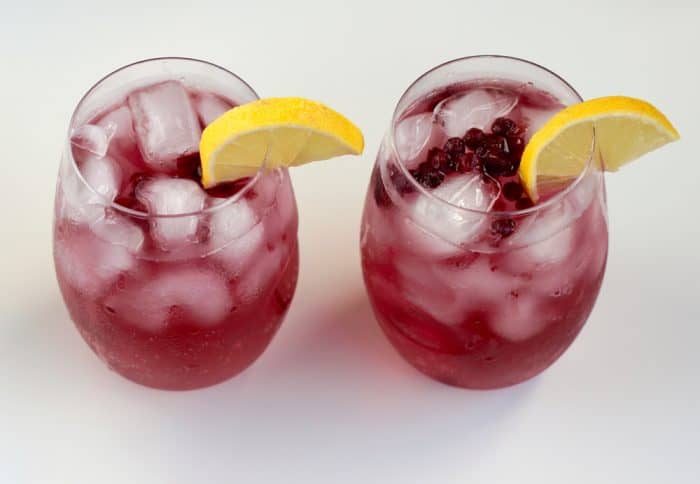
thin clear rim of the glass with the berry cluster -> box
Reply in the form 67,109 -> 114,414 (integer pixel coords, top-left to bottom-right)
388,54 -> 596,218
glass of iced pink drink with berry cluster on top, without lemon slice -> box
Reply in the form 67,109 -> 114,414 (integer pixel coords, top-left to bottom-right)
361,57 -> 608,388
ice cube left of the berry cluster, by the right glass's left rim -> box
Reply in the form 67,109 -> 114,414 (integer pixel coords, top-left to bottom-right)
394,113 -> 447,169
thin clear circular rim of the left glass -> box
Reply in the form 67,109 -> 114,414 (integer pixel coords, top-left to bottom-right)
64,56 -> 267,218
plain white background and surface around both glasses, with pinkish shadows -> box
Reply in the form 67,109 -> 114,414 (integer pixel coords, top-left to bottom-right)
0,0 -> 700,484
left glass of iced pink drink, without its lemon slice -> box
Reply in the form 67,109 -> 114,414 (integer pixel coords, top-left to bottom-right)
54,59 -> 298,389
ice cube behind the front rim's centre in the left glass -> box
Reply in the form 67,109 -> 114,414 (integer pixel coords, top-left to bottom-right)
136,178 -> 206,250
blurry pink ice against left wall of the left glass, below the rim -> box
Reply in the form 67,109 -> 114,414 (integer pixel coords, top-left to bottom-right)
54,229 -> 137,297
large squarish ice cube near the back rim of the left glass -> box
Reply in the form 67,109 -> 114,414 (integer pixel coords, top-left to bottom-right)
128,81 -> 201,170
